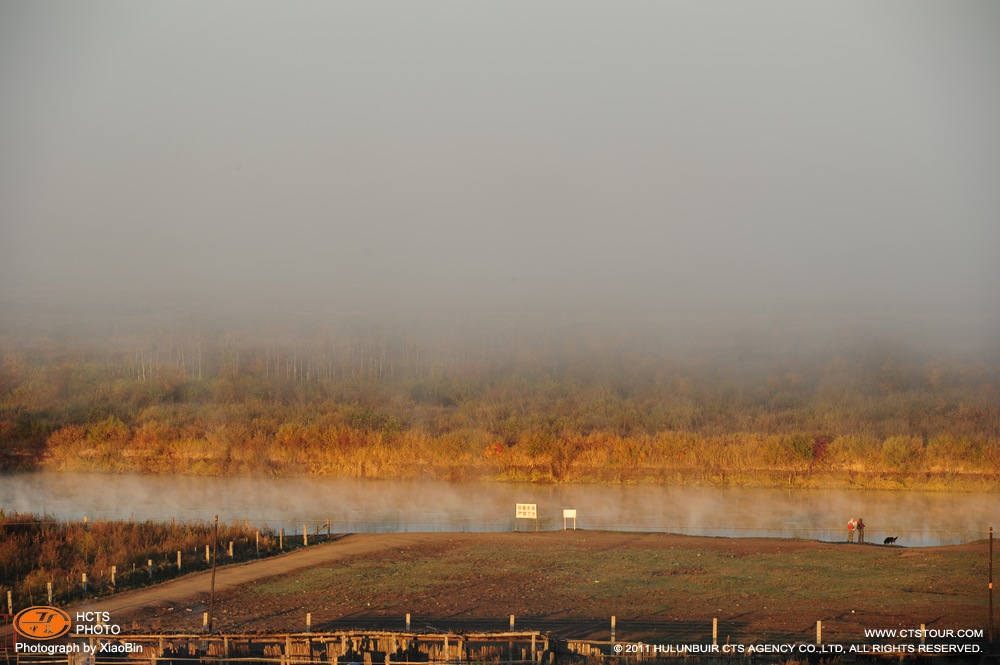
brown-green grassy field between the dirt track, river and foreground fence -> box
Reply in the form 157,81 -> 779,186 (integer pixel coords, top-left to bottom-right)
117,530 -> 988,644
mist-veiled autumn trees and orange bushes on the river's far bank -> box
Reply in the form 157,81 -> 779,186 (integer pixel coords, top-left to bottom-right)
0,314 -> 1000,490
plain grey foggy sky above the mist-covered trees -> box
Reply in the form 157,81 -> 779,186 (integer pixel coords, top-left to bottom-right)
0,0 -> 1000,340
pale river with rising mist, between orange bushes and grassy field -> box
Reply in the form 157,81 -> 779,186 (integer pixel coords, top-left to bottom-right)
0,473 -> 1000,546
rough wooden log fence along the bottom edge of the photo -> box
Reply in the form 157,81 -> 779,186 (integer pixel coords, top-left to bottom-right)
3,617 -> 985,665
